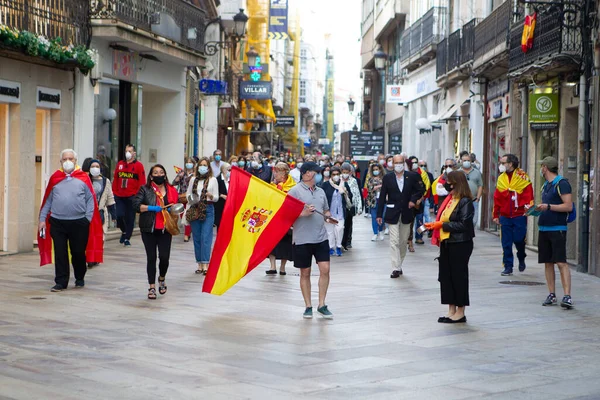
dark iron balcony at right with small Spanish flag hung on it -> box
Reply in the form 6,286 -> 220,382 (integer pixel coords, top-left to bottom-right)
508,7 -> 581,76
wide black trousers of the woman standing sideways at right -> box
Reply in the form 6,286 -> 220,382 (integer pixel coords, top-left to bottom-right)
438,240 -> 473,307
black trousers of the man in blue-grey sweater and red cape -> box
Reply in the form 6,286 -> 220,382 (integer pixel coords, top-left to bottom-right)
50,218 -> 90,289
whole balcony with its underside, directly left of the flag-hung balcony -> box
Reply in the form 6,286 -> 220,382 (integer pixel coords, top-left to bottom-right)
473,1 -> 511,79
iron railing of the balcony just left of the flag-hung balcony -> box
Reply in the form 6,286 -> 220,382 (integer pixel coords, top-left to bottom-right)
474,1 -> 511,59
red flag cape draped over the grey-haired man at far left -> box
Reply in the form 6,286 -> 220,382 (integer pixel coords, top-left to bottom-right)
38,167 -> 104,267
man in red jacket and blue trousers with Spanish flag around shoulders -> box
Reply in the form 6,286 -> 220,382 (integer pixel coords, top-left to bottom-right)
493,154 -> 533,276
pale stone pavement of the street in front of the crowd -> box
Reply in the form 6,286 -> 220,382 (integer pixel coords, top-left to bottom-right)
0,216 -> 600,400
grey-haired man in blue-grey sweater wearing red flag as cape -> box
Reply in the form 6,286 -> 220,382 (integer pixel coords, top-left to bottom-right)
38,149 -> 104,292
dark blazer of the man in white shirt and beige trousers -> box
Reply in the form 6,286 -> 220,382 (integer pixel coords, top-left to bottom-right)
377,171 -> 425,224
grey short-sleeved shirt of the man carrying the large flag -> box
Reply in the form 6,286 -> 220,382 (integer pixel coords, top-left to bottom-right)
288,182 -> 329,245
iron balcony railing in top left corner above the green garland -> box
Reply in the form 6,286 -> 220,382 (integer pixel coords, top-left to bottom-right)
0,0 -> 89,45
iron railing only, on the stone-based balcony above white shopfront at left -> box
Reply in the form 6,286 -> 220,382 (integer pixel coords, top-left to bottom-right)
89,0 -> 208,52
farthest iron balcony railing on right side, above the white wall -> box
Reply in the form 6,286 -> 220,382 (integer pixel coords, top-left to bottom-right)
400,7 -> 446,62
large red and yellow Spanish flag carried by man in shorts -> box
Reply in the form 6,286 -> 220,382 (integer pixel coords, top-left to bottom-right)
202,167 -> 304,295
